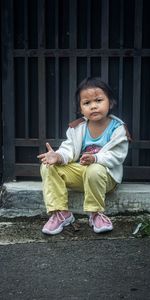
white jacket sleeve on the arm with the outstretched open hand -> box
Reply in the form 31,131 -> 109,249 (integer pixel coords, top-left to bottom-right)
56,128 -> 75,164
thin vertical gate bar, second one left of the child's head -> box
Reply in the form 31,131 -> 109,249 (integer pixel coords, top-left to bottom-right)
55,0 -> 59,139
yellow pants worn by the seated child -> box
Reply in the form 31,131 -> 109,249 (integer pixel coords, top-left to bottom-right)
41,163 -> 116,213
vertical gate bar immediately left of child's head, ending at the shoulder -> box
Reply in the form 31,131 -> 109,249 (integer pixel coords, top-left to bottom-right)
69,0 -> 77,121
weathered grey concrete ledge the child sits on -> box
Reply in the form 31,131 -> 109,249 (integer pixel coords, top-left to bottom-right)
0,181 -> 150,217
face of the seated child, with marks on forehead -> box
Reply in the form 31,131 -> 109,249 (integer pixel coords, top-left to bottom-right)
80,88 -> 111,121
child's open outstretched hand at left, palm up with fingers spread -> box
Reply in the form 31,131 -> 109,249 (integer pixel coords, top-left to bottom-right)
37,143 -> 61,166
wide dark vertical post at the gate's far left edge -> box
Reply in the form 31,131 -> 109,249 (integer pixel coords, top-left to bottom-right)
2,0 -> 15,181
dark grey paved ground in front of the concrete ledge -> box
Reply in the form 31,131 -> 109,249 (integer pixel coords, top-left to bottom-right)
0,216 -> 150,300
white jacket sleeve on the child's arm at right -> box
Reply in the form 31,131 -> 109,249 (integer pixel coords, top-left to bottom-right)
96,125 -> 129,169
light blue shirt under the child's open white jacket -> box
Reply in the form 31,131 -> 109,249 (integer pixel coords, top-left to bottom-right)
82,119 -> 121,154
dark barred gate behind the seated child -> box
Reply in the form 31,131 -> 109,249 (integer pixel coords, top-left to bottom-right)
1,0 -> 150,181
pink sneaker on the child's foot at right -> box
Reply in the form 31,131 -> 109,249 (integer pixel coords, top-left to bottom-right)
89,212 -> 113,233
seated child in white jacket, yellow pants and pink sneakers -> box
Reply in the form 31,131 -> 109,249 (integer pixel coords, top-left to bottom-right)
38,78 -> 128,234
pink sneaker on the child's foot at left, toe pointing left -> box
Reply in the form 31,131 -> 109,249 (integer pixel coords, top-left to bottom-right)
42,211 -> 75,234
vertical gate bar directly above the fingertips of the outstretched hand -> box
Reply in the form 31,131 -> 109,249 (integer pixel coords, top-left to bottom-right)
38,0 -> 46,151
